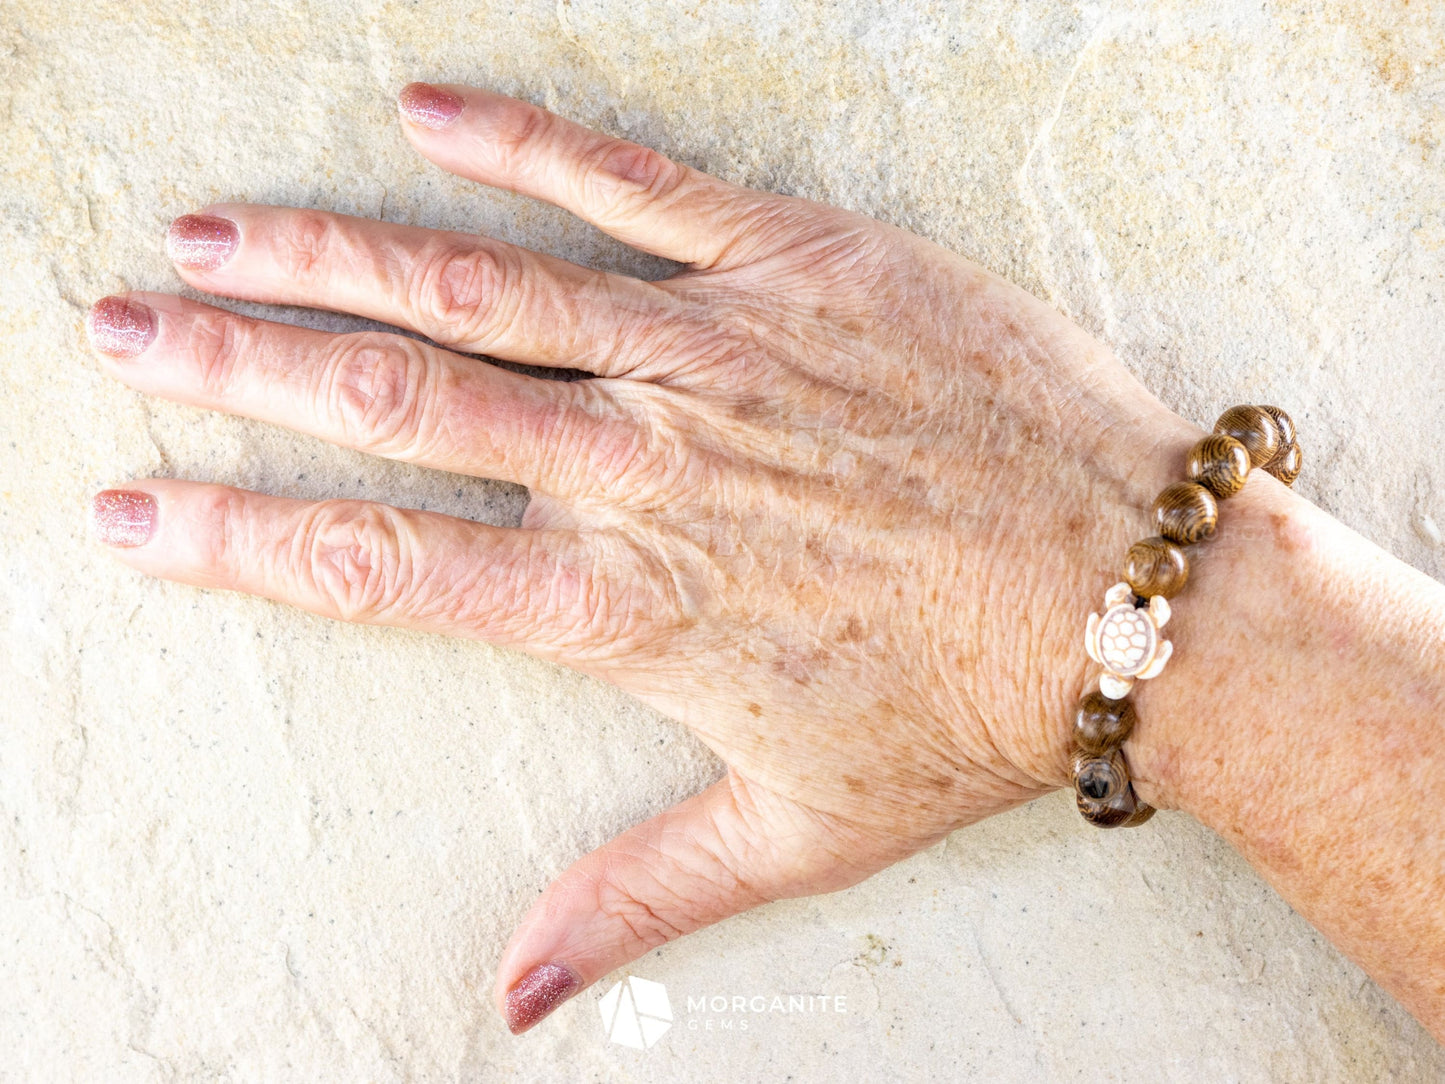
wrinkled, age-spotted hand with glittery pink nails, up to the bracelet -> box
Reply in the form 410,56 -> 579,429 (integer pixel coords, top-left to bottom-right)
90,85 -> 1201,1031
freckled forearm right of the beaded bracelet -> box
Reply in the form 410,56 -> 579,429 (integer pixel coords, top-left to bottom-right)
1127,450 -> 1445,1039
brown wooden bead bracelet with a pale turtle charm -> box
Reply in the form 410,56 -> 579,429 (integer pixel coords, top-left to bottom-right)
1072,406 -> 1299,828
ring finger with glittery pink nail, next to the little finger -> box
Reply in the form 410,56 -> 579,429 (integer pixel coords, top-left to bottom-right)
166,204 -> 681,376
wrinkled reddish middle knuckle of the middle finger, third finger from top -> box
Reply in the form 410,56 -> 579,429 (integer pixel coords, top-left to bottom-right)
325,332 -> 436,455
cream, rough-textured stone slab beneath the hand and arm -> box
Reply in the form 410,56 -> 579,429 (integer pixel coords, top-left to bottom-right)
0,0 -> 1445,1081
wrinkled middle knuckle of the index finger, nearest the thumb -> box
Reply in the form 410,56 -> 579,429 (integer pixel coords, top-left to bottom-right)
293,500 -> 412,621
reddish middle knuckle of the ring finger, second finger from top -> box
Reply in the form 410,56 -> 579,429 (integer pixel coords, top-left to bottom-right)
410,243 -> 519,347
